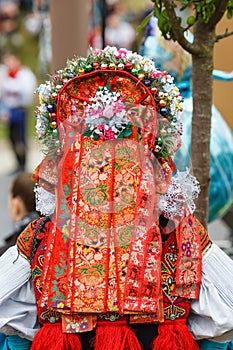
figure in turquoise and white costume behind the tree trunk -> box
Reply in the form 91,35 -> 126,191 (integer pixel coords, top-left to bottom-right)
140,15 -> 233,222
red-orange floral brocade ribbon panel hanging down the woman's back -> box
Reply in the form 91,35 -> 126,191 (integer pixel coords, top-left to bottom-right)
36,126 -> 166,312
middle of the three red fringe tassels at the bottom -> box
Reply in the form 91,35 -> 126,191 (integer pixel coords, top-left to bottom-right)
94,320 -> 142,350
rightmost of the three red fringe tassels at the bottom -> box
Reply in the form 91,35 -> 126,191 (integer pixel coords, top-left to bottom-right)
153,320 -> 200,350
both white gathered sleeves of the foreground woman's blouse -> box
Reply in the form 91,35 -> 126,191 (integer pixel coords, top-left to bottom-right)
0,243 -> 233,342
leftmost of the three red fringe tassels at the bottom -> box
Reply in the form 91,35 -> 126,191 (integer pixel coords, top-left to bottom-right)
30,323 -> 82,350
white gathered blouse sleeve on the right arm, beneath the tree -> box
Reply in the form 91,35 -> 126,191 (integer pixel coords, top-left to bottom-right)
188,243 -> 233,342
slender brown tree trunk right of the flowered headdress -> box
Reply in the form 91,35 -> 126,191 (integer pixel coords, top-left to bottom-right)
191,22 -> 215,227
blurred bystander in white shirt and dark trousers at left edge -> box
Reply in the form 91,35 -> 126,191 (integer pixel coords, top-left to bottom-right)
0,52 -> 36,173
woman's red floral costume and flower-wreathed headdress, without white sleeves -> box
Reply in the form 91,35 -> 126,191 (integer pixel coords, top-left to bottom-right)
0,47 -> 232,350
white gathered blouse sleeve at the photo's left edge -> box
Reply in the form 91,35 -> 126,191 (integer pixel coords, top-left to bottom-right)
0,246 -> 40,340
